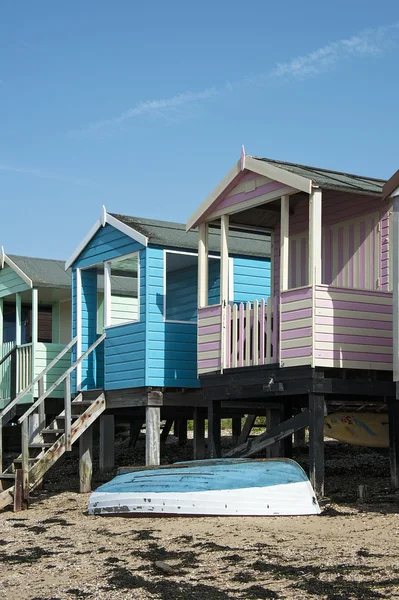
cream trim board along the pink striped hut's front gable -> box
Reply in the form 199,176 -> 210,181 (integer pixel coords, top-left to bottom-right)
186,155 -> 312,231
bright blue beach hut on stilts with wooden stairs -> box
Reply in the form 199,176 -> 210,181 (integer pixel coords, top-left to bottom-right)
0,209 -> 271,506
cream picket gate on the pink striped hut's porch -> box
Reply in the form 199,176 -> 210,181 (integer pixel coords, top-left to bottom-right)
225,298 -> 278,368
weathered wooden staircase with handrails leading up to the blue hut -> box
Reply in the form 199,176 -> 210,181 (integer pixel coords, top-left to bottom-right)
0,334 -> 105,510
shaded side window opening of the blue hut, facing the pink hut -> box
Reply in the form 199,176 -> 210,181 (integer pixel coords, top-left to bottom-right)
164,251 -> 220,323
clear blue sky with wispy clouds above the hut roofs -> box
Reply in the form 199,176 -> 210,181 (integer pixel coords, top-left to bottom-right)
0,0 -> 399,259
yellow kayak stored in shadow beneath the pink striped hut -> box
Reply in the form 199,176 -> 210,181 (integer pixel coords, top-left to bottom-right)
324,413 -> 389,448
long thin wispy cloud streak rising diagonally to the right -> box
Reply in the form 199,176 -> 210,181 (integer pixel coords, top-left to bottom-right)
68,23 -> 399,138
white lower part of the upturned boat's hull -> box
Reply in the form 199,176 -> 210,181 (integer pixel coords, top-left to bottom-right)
89,481 -> 320,516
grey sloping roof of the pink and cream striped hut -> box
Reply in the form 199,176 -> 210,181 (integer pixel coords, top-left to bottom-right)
253,156 -> 386,195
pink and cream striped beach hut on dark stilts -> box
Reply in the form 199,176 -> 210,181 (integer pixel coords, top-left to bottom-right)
187,151 -> 399,496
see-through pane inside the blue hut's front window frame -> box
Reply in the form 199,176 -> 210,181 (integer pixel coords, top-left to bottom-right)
111,254 -> 139,325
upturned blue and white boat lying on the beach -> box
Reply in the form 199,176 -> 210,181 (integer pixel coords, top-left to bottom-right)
88,460 -> 320,516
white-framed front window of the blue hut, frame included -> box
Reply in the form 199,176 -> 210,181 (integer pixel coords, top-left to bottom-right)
104,253 -> 140,326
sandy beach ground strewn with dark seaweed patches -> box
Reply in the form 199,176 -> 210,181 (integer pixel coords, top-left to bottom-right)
0,432 -> 399,600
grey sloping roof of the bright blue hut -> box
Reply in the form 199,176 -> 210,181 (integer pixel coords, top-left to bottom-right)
112,214 -> 271,257
